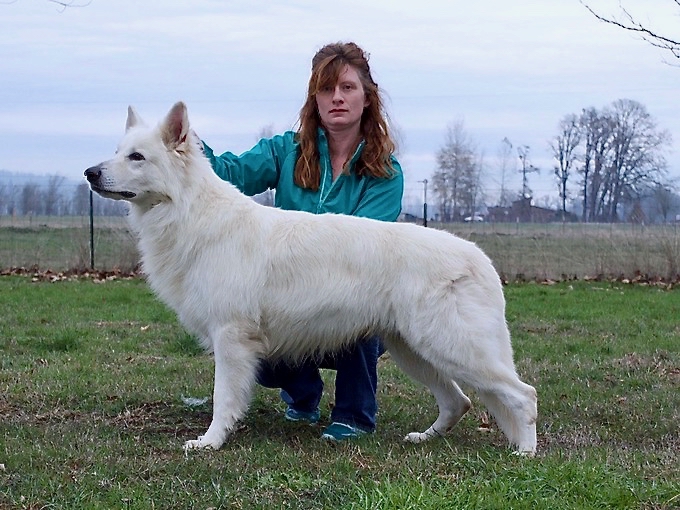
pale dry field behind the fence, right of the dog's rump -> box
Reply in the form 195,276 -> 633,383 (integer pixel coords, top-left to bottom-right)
439,223 -> 680,281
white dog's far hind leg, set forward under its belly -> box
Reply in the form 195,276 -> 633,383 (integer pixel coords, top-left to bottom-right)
389,342 -> 470,443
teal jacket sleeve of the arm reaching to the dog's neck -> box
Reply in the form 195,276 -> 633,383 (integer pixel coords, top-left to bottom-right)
203,135 -> 291,196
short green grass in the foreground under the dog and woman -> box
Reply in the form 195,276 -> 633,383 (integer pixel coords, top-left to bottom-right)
0,277 -> 680,510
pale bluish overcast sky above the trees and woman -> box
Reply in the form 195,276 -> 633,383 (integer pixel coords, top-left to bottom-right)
0,0 -> 680,207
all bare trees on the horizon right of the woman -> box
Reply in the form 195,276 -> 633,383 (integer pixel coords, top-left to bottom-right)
431,99 -> 677,222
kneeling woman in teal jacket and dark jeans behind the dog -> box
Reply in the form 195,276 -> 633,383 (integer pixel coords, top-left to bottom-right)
204,43 -> 404,441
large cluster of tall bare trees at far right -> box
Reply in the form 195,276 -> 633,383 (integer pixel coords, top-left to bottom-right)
551,99 -> 671,222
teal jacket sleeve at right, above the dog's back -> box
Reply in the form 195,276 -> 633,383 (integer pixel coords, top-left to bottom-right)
352,159 -> 404,221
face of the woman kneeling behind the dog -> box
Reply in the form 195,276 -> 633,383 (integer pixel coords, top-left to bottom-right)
316,65 -> 368,131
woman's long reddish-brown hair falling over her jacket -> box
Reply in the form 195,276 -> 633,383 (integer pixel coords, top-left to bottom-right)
295,42 -> 395,190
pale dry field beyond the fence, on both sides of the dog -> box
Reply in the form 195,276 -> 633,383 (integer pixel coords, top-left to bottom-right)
0,217 -> 680,281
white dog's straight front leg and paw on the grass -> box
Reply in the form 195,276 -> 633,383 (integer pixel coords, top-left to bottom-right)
184,327 -> 259,449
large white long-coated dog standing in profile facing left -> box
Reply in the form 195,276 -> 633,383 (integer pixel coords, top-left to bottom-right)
85,103 -> 537,454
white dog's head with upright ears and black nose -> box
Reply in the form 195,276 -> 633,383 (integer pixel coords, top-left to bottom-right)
85,102 -> 202,207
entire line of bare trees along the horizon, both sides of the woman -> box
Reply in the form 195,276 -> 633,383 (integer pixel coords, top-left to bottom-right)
0,99 -> 680,222
